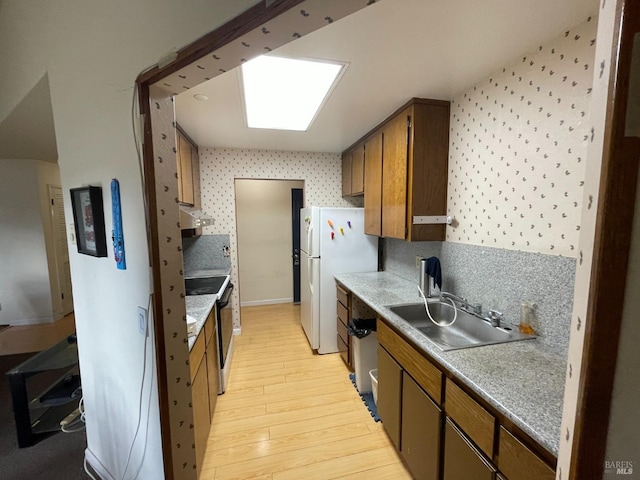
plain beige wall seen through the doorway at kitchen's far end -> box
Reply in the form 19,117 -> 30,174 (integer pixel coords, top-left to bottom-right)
235,179 -> 304,306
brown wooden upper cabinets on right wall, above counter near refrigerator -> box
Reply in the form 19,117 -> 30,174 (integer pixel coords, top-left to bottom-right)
343,98 -> 449,241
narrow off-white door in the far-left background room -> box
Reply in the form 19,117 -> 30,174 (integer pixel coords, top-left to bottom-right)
49,185 -> 73,315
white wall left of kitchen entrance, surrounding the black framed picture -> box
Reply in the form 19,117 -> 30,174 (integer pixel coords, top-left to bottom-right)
0,0 -> 257,479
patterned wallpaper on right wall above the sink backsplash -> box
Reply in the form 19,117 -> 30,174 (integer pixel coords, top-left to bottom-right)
447,18 -> 597,257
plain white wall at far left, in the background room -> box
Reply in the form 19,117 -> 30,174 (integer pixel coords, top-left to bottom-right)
0,160 -> 53,325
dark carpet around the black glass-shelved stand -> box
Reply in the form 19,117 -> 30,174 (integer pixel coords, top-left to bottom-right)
0,353 -> 88,480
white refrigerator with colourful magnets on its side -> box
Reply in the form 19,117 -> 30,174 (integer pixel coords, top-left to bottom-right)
300,207 -> 378,354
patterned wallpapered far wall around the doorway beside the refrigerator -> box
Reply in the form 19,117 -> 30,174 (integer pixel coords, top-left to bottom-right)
199,147 -> 362,328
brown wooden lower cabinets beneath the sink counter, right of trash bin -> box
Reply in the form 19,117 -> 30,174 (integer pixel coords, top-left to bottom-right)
376,318 -> 555,480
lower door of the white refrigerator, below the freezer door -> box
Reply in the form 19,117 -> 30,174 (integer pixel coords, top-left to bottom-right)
300,253 -> 320,350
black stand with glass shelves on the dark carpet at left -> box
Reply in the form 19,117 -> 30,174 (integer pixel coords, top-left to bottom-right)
6,333 -> 82,448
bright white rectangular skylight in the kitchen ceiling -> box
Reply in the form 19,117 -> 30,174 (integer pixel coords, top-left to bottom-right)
242,56 -> 345,131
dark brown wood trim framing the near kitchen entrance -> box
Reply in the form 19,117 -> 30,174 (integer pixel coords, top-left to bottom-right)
136,0 -> 640,479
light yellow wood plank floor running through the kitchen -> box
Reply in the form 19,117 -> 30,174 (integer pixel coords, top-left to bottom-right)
200,304 -> 411,480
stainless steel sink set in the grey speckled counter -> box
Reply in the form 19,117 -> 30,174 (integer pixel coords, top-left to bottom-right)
387,301 -> 535,350
